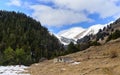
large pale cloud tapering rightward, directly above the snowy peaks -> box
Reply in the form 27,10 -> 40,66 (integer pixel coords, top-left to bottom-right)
31,5 -> 91,26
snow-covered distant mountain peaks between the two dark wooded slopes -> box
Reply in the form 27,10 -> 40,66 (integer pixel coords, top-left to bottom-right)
56,24 -> 107,45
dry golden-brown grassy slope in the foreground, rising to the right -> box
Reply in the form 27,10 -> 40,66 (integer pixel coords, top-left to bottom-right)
29,39 -> 120,75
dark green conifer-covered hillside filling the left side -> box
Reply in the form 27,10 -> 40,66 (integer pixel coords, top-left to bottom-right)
0,10 -> 62,65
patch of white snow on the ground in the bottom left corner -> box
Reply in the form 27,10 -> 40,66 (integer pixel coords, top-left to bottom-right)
0,65 -> 30,75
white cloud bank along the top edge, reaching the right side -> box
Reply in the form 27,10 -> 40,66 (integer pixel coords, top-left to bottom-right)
52,0 -> 120,18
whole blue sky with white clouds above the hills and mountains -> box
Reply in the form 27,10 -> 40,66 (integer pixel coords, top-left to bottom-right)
0,0 -> 120,34
